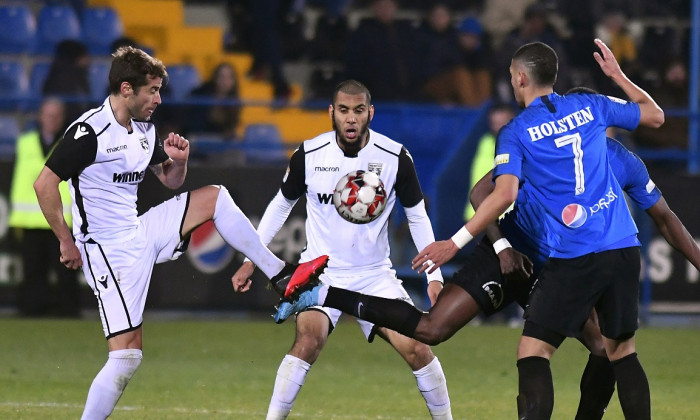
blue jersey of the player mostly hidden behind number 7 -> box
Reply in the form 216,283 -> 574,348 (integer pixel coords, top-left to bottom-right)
500,138 -> 661,273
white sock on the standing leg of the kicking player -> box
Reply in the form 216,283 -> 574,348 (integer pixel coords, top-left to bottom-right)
82,349 -> 142,420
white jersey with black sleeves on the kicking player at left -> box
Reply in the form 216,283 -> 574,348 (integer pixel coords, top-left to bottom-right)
46,97 -> 168,244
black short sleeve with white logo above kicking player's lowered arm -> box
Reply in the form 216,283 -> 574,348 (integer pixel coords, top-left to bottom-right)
46,122 -> 97,181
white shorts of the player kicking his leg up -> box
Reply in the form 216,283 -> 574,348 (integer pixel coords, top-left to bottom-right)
79,193 -> 189,339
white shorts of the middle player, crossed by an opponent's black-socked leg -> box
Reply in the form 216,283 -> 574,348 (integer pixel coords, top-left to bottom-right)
310,268 -> 415,342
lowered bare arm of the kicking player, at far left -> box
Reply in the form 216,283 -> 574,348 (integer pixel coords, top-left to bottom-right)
34,166 -> 83,270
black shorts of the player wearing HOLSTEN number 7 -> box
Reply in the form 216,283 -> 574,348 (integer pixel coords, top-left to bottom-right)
524,247 -> 641,340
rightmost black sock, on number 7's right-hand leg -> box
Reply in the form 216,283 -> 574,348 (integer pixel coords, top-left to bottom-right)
611,353 -> 651,420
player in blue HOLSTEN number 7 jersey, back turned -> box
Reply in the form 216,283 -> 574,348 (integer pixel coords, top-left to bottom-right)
278,40 -> 664,419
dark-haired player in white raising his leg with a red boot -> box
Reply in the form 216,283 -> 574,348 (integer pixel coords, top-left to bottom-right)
34,47 -> 327,420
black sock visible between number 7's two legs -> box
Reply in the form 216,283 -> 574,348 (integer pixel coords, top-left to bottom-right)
576,354 -> 615,420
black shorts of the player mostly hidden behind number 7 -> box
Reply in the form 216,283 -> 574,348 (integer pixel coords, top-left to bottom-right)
447,239 -> 535,315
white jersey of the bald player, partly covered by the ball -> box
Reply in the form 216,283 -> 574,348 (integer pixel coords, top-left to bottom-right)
281,130 -> 424,275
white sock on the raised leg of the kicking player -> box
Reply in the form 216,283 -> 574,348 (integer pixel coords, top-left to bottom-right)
214,185 -> 284,278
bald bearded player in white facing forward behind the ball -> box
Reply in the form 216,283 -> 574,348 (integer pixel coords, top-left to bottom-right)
232,80 -> 452,420
